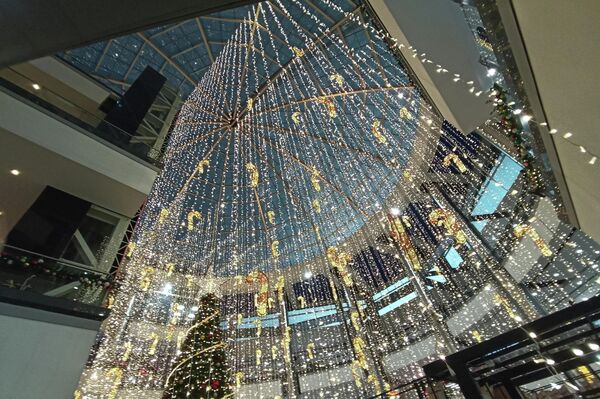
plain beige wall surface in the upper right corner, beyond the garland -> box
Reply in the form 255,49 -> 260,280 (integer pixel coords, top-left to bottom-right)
508,0 -> 600,241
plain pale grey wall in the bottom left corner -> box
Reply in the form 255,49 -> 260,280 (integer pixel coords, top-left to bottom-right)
0,303 -> 98,399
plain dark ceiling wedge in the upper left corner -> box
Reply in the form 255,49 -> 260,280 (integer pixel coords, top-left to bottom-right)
0,0 -> 256,68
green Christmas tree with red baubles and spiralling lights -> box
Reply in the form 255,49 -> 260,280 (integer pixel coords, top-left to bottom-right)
163,293 -> 233,399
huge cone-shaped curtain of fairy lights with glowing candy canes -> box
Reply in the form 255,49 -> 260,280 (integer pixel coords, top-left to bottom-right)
76,0 -> 597,398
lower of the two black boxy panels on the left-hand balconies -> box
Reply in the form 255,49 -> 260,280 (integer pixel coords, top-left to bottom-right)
6,186 -> 91,258
